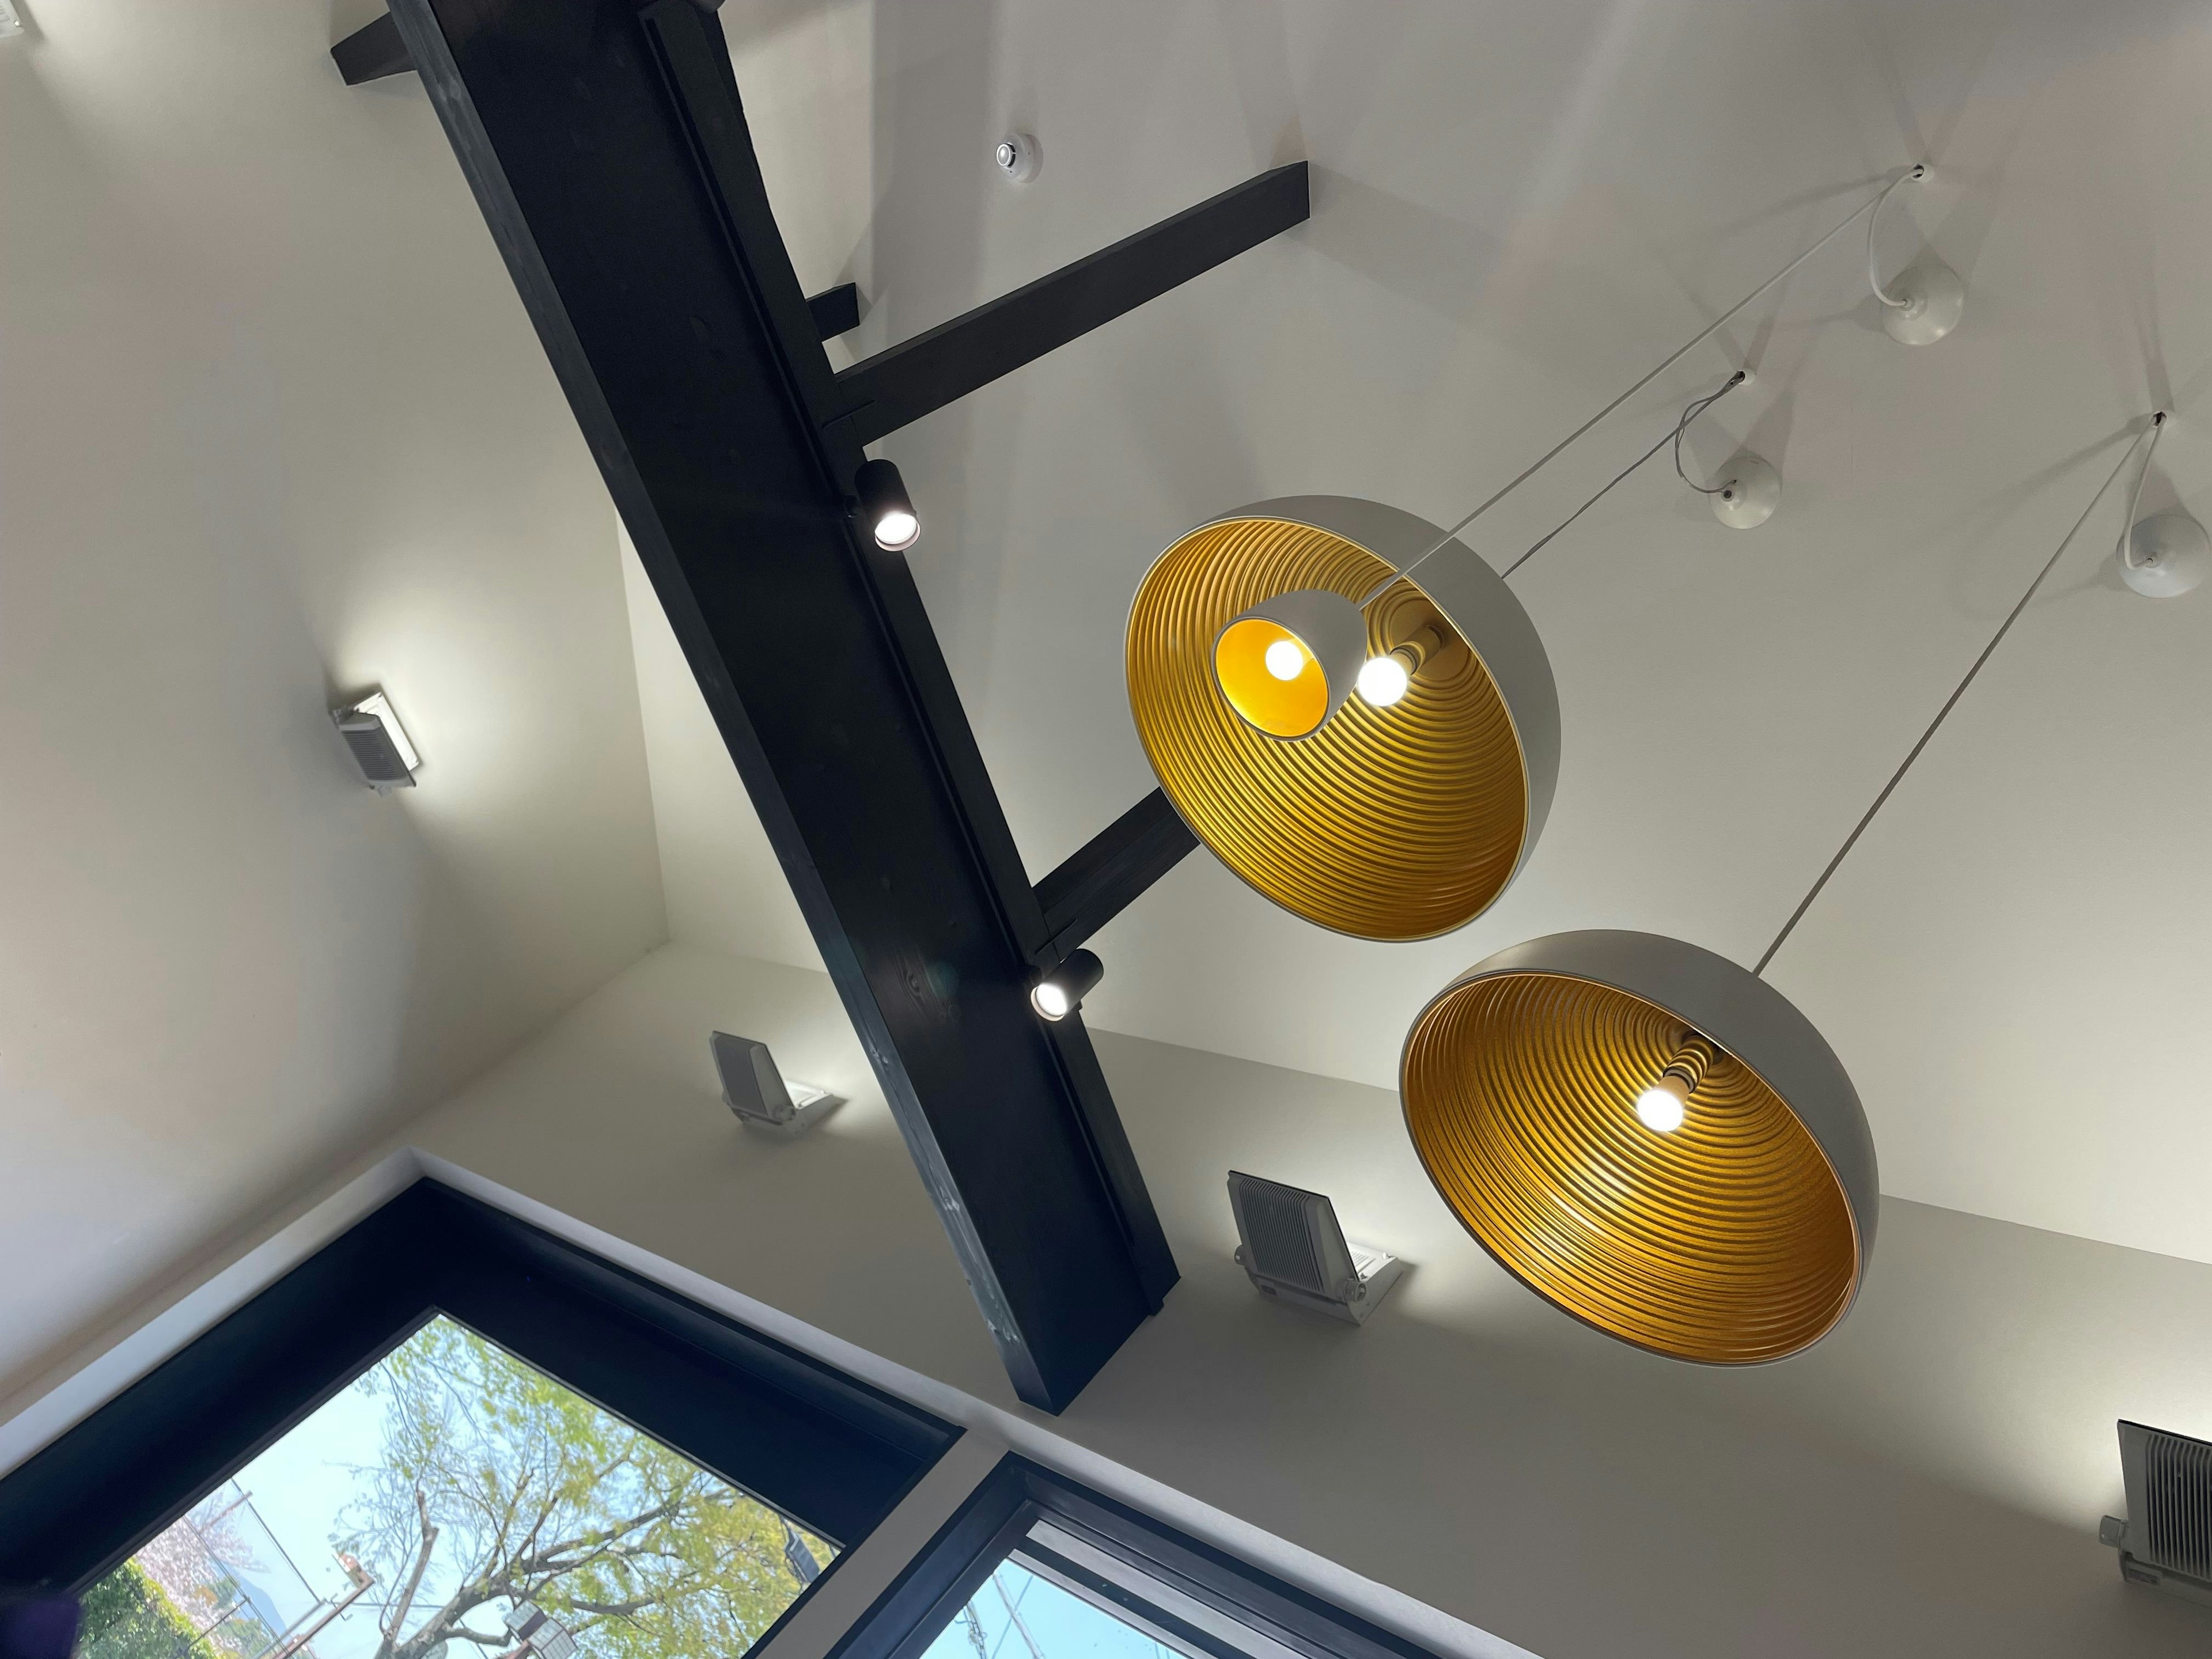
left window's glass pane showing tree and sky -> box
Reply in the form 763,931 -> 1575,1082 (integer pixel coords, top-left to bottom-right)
77,1319 -> 836,1659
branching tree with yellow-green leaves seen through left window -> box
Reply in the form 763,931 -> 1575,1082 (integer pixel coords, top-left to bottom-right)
332,1319 -> 832,1659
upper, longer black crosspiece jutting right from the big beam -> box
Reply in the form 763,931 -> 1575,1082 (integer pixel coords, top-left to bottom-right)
836,161 -> 1309,445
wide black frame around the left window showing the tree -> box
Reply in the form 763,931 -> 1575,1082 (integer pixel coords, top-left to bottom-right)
0,1177 -> 960,1601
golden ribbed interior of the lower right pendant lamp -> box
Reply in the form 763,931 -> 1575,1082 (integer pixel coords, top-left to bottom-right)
1400,974 -> 1858,1365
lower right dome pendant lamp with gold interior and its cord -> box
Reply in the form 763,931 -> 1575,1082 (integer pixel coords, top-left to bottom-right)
1398,414 -> 2157,1365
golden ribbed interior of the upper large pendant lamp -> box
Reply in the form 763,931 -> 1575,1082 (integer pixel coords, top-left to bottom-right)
1128,518 -> 1528,940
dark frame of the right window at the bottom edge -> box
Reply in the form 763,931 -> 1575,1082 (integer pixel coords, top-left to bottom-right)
827,1453 -> 1435,1659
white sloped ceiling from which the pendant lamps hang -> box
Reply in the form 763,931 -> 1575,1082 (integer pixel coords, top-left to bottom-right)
632,0 -> 2212,1261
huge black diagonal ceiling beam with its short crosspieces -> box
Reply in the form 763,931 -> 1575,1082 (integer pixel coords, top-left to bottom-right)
378,0 -> 1307,1411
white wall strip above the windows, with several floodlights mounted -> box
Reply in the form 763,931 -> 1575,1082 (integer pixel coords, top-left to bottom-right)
411,945 -> 2212,1659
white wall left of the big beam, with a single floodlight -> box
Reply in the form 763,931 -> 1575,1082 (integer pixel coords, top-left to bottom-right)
0,0 -> 666,1398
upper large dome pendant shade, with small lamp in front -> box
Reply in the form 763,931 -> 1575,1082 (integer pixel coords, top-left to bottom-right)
1126,495 -> 1559,940
